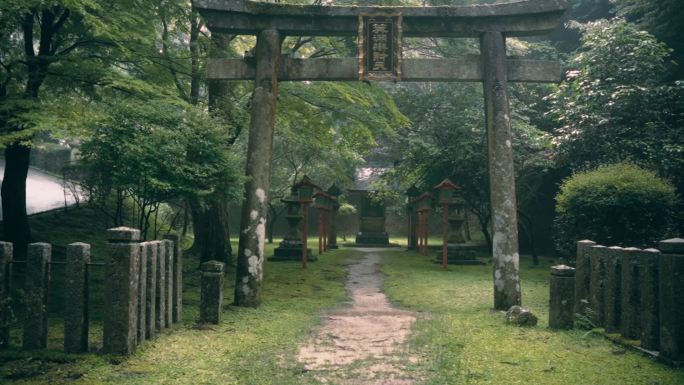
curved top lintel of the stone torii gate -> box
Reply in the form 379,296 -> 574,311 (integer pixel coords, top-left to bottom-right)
193,0 -> 570,37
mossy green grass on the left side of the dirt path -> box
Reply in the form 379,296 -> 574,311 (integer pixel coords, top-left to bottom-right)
0,206 -> 360,385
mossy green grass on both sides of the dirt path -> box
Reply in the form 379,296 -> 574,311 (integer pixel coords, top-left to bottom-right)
0,208 -> 684,385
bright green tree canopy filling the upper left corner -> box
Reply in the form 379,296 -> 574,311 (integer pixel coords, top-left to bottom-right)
0,0 -> 159,147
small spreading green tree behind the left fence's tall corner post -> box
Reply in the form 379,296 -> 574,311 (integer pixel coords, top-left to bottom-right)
81,99 -> 242,237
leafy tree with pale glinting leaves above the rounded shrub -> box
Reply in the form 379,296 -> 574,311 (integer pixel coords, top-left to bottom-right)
549,19 -> 684,191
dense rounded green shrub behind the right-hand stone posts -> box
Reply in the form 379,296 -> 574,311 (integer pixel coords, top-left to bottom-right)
555,163 -> 677,256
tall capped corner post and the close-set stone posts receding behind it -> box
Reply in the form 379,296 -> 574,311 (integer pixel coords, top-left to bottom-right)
103,227 -> 183,355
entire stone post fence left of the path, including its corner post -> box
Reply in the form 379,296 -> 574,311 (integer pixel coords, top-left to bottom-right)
0,227 -> 183,354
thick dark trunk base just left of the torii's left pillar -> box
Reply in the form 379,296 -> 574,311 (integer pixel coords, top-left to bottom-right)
189,196 -> 233,265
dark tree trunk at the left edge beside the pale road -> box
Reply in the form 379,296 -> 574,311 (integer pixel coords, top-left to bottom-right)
2,143 -> 31,258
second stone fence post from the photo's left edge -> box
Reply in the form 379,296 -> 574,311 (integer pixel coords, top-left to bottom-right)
23,243 -> 52,349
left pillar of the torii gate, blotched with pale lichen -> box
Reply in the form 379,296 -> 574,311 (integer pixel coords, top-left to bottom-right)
235,29 -> 281,307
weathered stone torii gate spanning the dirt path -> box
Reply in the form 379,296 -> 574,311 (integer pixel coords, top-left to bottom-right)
193,0 -> 570,310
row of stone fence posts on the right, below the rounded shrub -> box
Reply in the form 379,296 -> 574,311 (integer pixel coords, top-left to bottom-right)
549,239 -> 684,363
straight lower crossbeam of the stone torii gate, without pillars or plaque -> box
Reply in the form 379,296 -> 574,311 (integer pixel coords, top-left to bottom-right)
207,56 -> 562,83
